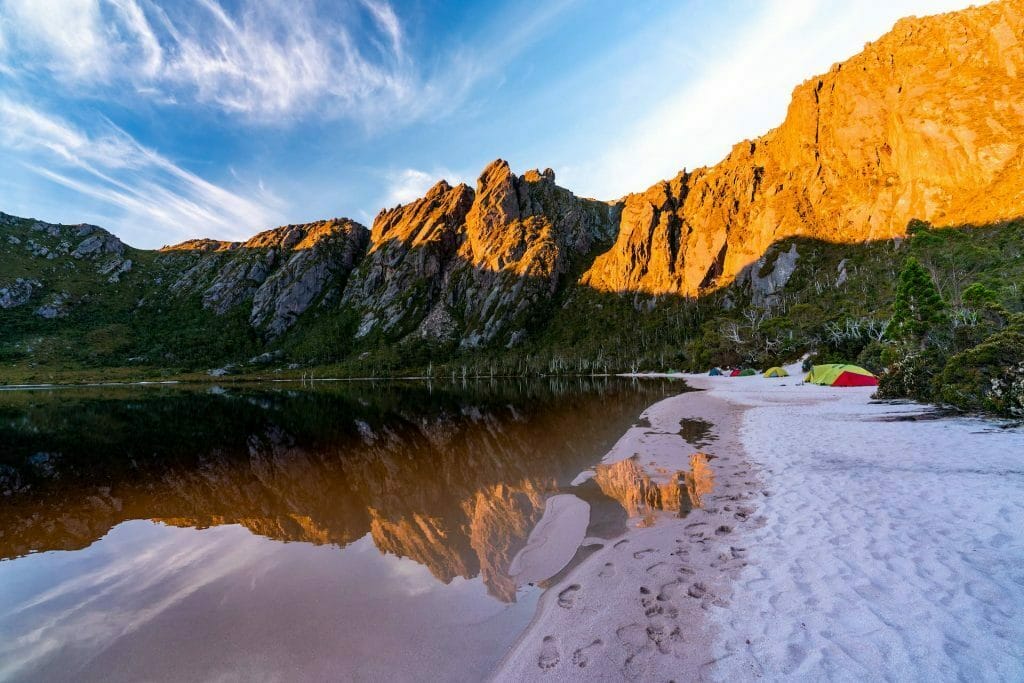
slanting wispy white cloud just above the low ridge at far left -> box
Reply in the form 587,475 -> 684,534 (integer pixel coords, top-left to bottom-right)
0,97 -> 282,242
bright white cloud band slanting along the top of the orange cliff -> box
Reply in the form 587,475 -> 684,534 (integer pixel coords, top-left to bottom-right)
559,0 -> 968,199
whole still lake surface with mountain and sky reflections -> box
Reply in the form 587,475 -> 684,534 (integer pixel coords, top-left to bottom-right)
0,380 -> 683,681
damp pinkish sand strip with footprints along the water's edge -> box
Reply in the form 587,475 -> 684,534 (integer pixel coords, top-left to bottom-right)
493,376 -> 763,681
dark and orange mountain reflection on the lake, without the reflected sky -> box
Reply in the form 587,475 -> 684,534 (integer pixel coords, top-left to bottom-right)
0,379 -> 682,602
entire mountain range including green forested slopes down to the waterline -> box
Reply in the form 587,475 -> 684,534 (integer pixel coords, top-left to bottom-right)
0,0 -> 1024,411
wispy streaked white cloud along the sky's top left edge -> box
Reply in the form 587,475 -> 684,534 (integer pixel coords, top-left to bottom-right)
0,0 -> 438,124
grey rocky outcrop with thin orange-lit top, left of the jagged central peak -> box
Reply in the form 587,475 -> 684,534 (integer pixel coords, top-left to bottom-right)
167,218 -> 369,338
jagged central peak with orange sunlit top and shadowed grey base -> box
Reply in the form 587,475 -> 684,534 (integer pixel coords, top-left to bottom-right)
345,160 -> 614,347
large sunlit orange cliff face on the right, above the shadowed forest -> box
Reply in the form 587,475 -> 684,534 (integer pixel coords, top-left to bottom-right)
583,0 -> 1024,296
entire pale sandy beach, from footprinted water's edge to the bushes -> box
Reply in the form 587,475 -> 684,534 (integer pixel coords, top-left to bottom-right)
495,366 -> 1024,681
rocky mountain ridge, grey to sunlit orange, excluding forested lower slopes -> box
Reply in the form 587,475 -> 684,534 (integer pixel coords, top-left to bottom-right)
0,0 -> 1024,366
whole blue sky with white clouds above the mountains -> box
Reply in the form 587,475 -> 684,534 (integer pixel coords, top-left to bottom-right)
0,0 -> 970,248
